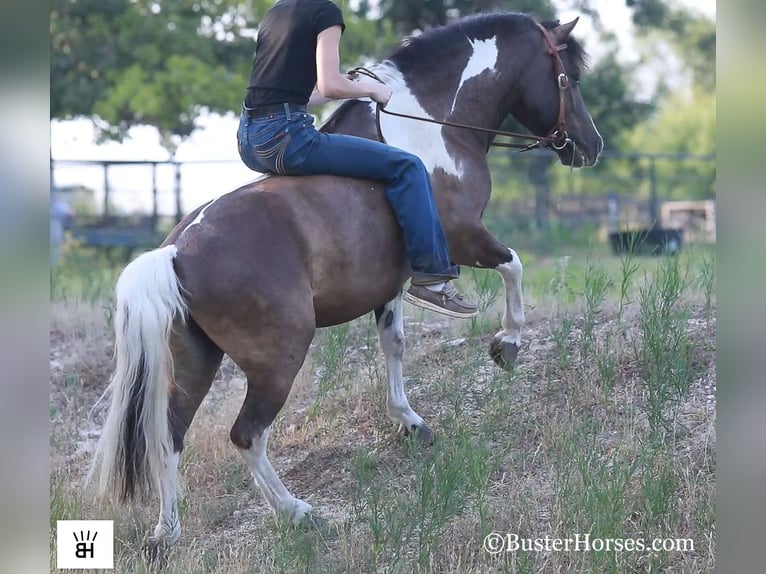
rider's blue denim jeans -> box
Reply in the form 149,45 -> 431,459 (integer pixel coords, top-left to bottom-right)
237,106 -> 460,285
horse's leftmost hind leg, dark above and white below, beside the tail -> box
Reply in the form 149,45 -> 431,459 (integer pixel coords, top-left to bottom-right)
146,318 -> 223,561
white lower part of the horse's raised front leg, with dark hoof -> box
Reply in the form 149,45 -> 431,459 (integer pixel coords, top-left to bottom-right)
489,249 -> 524,370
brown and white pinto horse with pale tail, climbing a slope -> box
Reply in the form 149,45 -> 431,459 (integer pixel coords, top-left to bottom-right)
89,13 -> 603,554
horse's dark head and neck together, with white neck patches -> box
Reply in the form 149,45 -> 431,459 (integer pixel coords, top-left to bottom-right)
323,12 -> 604,170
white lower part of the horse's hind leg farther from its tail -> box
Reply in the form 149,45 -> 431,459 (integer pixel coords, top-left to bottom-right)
237,427 -> 311,524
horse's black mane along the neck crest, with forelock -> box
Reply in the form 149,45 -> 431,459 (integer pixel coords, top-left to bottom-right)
325,12 -> 588,130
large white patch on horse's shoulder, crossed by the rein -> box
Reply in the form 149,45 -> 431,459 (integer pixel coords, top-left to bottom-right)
370,61 -> 463,178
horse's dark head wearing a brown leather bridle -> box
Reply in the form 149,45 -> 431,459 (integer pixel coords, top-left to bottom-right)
511,19 -> 604,167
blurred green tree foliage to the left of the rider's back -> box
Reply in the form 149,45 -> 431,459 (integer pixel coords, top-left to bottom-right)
50,0 -> 267,153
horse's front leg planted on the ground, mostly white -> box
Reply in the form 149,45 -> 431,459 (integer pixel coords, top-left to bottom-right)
375,293 -> 434,445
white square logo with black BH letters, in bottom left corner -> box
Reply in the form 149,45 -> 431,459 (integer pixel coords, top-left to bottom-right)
56,520 -> 114,569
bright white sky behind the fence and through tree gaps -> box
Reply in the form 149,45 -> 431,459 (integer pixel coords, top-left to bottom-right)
51,0 -> 716,214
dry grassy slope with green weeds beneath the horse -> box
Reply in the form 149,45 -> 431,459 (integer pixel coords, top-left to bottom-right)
50,242 -> 715,574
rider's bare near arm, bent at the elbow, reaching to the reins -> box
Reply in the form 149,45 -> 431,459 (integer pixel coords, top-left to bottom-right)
316,26 -> 391,105
